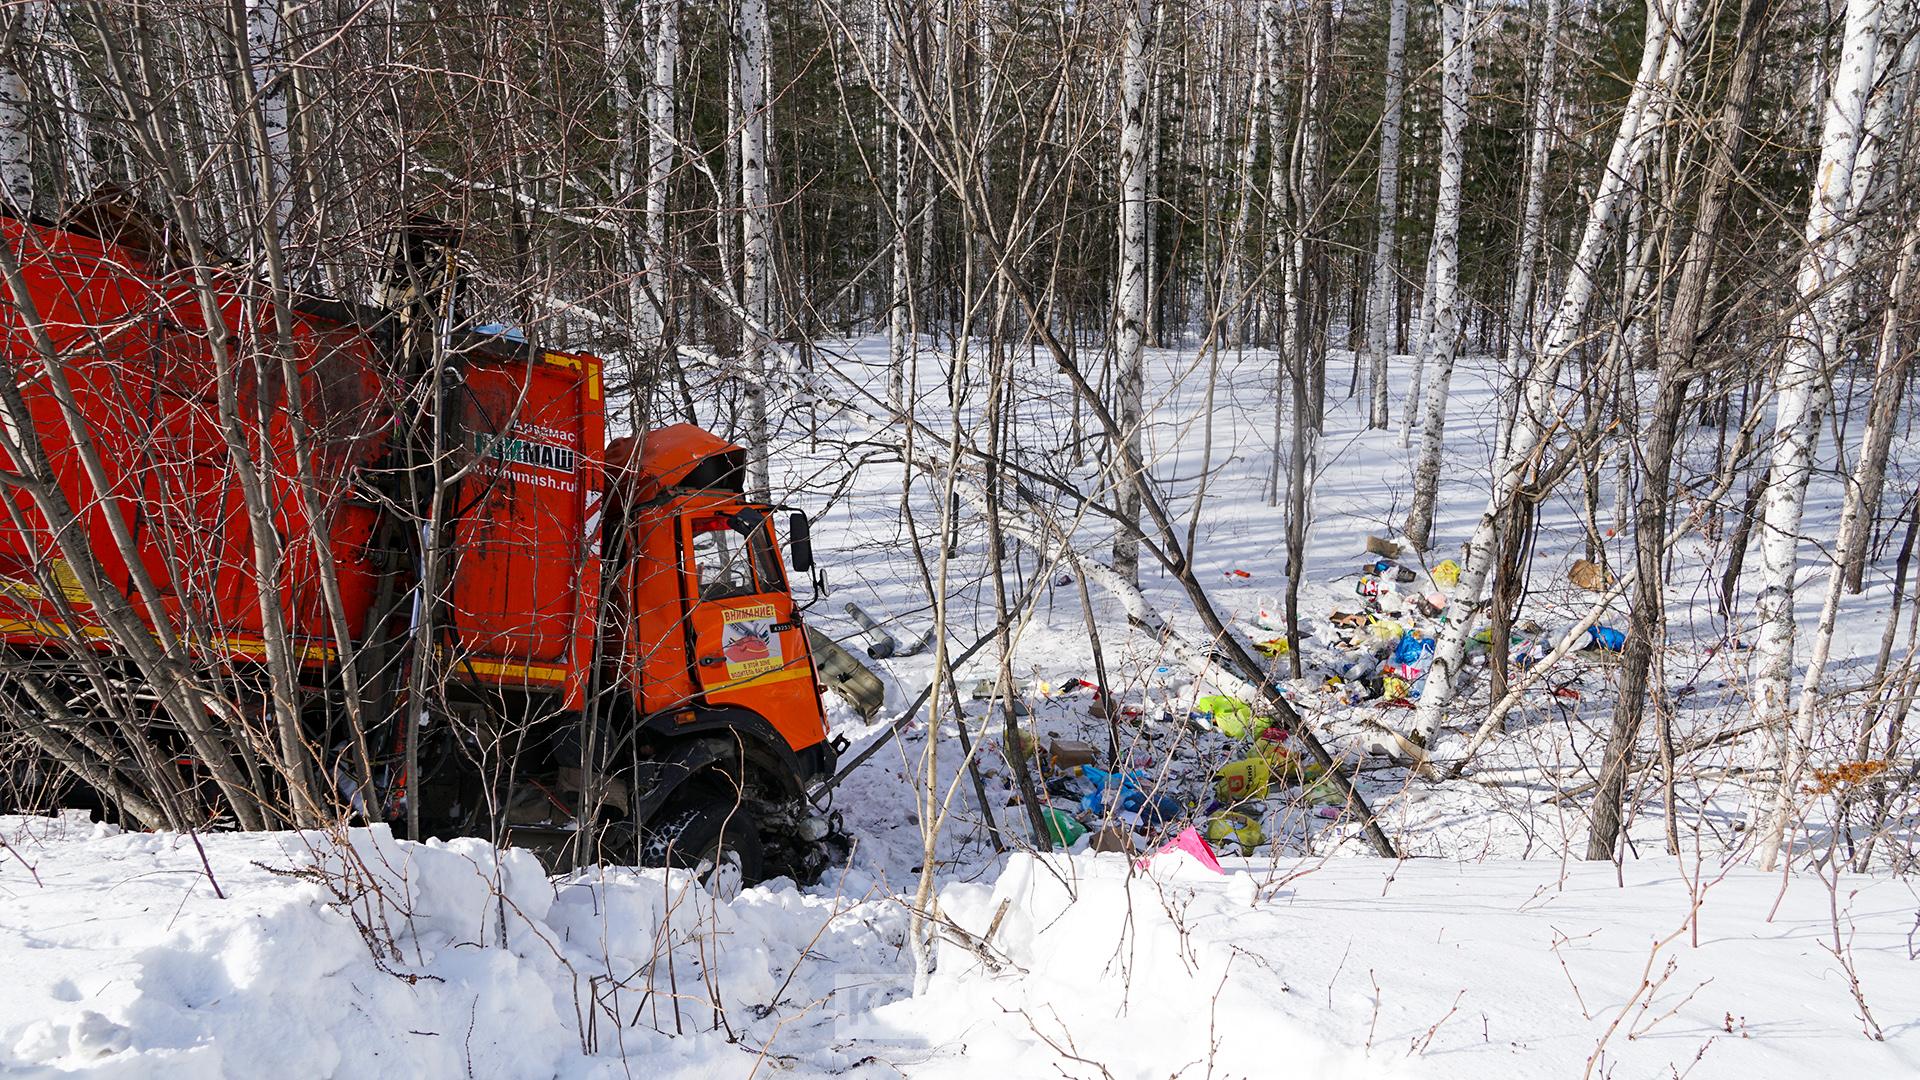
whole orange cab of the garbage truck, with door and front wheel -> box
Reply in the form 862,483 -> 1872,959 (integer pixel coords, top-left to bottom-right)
601,425 -> 835,876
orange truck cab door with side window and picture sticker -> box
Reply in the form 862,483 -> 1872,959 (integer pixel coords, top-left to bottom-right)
680,507 -> 826,749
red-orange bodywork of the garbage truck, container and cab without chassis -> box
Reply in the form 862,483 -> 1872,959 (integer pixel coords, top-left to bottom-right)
0,217 -> 831,876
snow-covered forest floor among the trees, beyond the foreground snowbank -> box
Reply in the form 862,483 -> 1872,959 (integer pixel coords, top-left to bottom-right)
776,342 -> 1920,872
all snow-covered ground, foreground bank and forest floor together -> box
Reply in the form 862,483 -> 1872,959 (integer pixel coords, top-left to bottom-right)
0,342 -> 1920,1078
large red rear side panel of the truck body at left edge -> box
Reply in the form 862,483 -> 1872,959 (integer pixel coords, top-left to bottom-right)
0,219 -> 384,661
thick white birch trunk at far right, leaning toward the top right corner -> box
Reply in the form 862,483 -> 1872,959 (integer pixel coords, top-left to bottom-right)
1753,0 -> 1884,869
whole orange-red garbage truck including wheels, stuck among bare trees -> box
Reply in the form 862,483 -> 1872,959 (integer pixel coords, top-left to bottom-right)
0,205 -> 843,878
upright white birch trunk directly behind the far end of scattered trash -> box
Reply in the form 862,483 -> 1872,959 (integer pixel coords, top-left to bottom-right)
1405,0 -> 1473,550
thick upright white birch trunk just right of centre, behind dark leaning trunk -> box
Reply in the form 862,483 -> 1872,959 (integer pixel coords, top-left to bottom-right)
1114,0 -> 1154,580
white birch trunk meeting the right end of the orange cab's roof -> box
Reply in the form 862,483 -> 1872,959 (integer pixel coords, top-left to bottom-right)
733,0 -> 774,500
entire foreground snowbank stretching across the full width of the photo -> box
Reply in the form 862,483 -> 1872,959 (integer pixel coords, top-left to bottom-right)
0,819 -> 1920,1080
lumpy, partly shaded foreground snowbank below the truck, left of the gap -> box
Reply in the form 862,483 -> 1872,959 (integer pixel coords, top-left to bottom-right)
0,819 -> 904,1078
